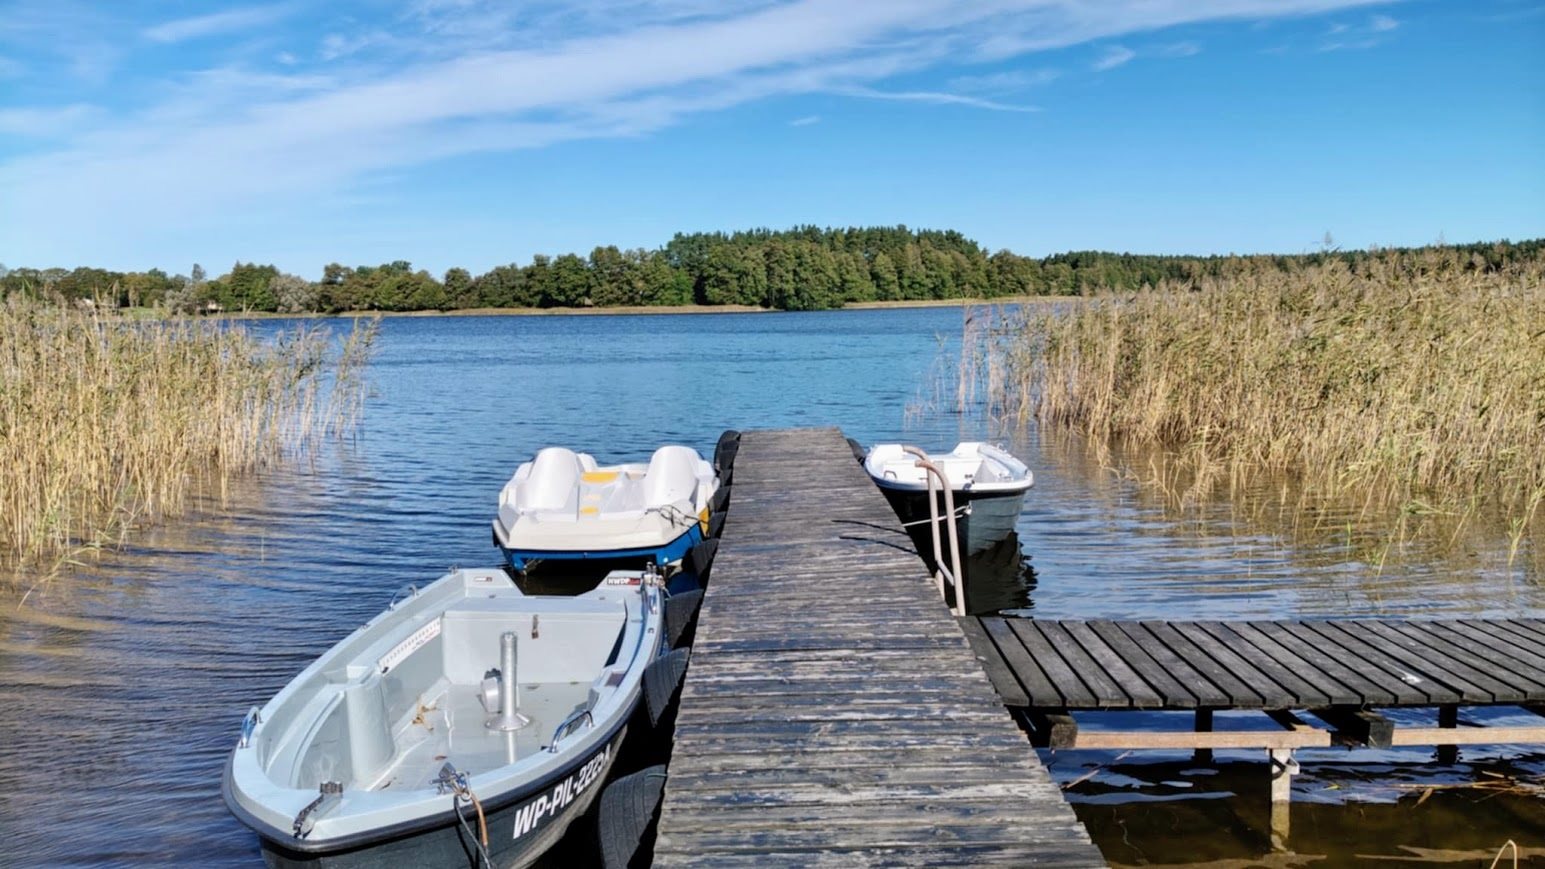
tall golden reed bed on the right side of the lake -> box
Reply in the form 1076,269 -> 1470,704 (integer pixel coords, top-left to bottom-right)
990,252 -> 1545,550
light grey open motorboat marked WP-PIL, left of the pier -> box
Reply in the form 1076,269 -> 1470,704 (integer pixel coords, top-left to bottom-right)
222,569 -> 670,866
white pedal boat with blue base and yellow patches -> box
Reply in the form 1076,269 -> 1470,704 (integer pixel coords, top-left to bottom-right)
493,444 -> 718,572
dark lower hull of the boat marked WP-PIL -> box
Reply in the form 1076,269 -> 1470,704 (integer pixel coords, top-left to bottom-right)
239,725 -> 627,869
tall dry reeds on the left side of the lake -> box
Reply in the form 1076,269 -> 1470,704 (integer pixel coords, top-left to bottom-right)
0,297 -> 374,563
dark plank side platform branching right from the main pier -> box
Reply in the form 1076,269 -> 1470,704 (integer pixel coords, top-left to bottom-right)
963,617 -> 1545,748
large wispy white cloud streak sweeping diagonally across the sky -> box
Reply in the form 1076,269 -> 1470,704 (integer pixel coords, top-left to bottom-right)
0,0 -> 1402,260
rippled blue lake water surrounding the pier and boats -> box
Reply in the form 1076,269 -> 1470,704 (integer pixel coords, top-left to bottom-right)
0,308 -> 1545,866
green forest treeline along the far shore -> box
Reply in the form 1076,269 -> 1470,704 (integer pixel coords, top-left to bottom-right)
0,226 -> 1545,314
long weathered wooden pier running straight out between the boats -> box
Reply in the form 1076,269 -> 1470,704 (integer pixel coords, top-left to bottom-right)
655,430 -> 1103,866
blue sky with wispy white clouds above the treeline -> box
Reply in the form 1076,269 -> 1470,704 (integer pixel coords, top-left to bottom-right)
0,0 -> 1545,277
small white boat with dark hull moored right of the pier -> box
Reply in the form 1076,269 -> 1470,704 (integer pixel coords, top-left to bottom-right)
864,441 -> 1035,555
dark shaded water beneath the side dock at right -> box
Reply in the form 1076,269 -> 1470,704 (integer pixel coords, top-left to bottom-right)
1054,742 -> 1545,867
